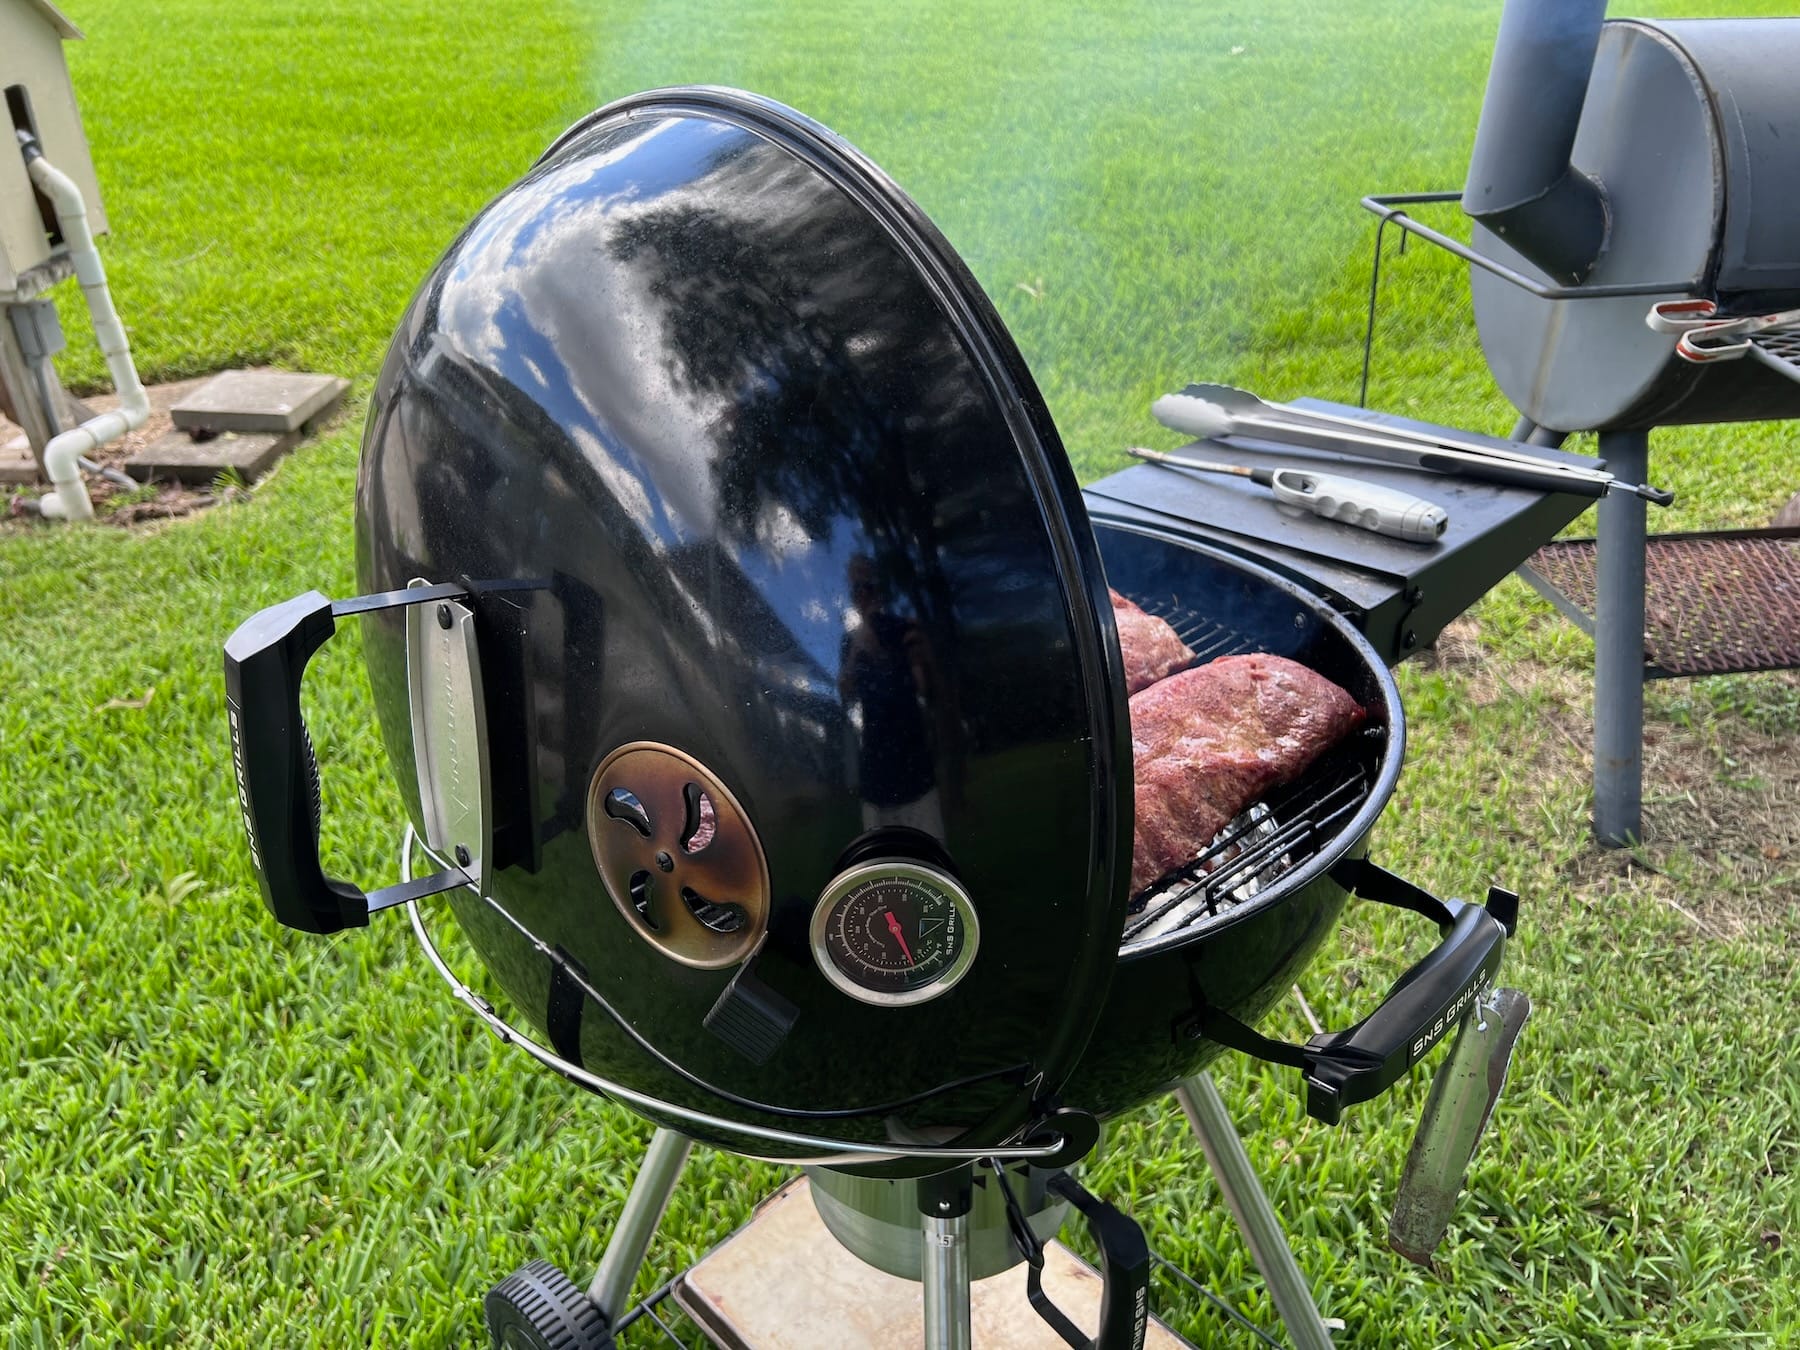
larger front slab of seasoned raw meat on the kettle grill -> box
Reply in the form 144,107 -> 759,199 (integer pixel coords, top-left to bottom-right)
1130,653 -> 1366,895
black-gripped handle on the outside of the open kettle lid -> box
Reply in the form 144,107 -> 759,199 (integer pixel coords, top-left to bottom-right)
225,585 -> 468,932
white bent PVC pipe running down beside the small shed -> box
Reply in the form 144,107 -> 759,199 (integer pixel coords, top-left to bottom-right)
27,155 -> 149,520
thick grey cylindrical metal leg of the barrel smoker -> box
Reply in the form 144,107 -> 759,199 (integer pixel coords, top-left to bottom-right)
1593,432 -> 1651,848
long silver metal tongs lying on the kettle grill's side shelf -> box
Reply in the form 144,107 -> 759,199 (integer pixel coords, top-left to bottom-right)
1150,385 -> 1676,506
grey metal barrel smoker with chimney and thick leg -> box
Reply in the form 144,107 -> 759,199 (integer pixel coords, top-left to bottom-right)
1364,0 -> 1800,844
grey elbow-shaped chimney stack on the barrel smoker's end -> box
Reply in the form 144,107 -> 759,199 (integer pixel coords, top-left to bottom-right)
1462,0 -> 1609,284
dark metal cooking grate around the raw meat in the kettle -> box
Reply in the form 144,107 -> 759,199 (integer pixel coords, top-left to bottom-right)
1120,598 -> 1384,947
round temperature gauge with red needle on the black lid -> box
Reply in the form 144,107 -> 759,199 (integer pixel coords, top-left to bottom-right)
812,859 -> 981,1008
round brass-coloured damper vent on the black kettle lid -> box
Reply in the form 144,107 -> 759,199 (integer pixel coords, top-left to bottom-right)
587,742 -> 769,970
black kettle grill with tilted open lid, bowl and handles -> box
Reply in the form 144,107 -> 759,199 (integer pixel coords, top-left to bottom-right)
225,88 -> 1514,1346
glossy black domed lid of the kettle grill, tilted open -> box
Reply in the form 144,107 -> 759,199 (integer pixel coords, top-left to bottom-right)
358,88 -> 1132,1152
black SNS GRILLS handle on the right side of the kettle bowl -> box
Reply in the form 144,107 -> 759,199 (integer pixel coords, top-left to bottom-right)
1195,871 -> 1519,1125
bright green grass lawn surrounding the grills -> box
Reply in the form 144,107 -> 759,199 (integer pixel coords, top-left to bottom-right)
0,0 -> 1800,1346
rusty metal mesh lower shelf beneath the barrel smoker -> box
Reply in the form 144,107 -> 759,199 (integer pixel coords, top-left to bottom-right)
1519,529 -> 1800,679
